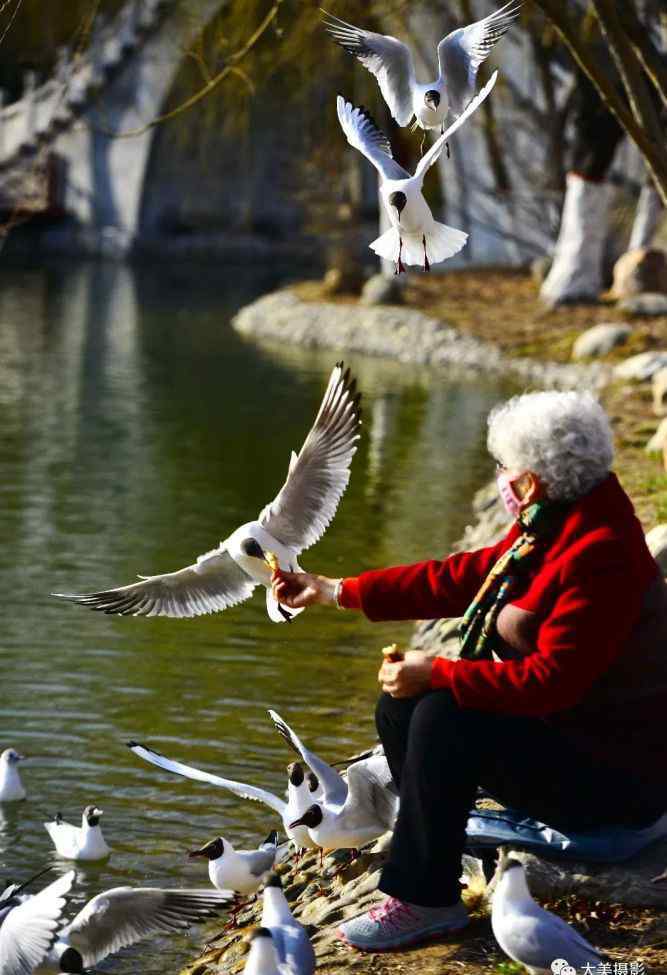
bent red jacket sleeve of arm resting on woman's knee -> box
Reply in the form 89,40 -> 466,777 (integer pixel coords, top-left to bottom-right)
431,545 -> 642,717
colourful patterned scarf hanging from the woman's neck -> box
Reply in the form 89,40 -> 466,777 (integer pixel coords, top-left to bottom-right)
458,501 -> 566,660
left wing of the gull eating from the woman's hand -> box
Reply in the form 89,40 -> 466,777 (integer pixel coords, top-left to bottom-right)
52,548 -> 256,619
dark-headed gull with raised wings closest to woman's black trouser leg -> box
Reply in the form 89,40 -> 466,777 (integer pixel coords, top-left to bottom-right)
269,711 -> 398,851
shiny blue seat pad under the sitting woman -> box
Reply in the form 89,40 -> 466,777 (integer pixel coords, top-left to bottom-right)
466,809 -> 667,863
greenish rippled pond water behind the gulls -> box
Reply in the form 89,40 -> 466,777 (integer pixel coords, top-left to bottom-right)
0,264 -> 507,975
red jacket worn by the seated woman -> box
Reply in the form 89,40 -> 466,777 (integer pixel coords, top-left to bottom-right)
341,474 -> 667,778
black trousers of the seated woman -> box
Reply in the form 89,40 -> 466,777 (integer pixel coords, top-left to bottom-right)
376,690 -> 664,907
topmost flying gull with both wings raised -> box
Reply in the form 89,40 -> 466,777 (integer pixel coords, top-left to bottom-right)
323,0 -> 521,132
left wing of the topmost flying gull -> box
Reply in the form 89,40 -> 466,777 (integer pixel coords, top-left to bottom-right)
322,10 -> 415,126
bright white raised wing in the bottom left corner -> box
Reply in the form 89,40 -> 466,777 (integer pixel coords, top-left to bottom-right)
0,870 -> 75,975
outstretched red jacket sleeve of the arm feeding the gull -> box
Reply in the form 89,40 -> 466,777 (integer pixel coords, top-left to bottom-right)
340,525 -> 519,622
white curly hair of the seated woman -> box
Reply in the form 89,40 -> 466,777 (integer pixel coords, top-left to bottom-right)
487,392 -> 614,501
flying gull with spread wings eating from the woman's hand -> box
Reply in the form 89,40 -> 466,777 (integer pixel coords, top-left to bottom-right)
53,362 -> 361,623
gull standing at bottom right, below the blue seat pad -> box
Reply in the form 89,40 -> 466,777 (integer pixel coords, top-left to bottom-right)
491,857 -> 602,975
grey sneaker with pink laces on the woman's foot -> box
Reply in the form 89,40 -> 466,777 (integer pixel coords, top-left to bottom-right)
336,897 -> 469,951
